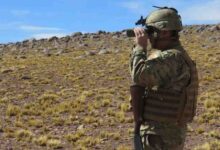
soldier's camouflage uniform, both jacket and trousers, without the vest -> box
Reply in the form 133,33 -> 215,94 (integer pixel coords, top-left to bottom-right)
130,42 -> 190,150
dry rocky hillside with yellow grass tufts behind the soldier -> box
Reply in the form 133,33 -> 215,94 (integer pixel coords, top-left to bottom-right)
0,25 -> 220,150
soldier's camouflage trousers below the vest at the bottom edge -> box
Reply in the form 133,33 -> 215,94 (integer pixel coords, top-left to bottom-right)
140,122 -> 186,150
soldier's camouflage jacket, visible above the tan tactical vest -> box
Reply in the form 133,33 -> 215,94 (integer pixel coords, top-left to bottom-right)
130,42 -> 190,91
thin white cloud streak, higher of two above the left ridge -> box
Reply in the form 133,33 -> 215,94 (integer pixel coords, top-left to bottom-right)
19,25 -> 63,31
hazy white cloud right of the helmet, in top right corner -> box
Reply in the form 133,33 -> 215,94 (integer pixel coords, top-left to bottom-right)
182,0 -> 220,22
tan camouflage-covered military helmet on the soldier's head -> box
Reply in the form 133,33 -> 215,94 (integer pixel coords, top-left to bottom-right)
145,7 -> 182,31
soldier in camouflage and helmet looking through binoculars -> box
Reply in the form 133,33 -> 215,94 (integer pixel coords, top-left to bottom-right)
130,7 -> 198,150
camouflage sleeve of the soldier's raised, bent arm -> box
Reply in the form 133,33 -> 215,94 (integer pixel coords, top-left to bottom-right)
131,50 -> 190,88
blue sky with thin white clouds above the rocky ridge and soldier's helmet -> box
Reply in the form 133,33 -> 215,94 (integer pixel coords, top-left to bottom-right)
0,0 -> 220,43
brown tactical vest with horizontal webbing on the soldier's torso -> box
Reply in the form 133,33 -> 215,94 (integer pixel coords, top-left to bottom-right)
143,51 -> 198,124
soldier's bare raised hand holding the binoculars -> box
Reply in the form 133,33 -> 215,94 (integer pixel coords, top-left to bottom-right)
134,27 -> 148,49
